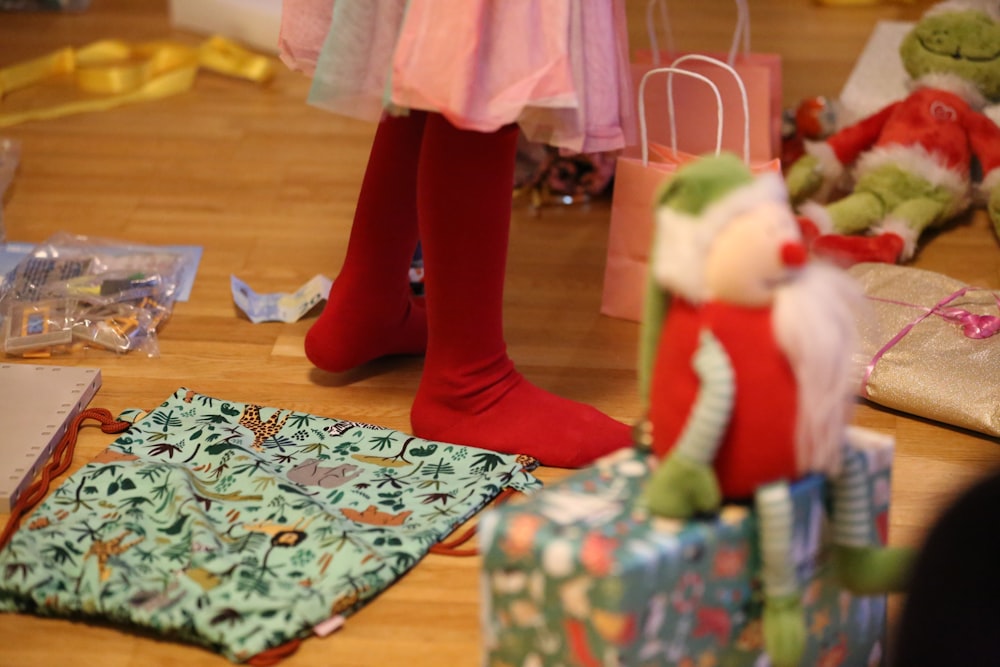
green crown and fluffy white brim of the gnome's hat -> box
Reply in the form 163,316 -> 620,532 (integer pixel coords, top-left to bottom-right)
651,153 -> 788,302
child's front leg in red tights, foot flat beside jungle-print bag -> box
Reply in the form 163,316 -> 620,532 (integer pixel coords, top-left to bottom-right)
411,114 -> 631,468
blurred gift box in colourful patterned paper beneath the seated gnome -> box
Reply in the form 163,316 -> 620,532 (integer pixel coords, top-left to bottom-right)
480,437 -> 892,667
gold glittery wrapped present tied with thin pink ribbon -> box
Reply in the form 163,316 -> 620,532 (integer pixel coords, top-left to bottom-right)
849,264 -> 1000,436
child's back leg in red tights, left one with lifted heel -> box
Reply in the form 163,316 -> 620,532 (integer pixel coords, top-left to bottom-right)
305,112 -> 427,372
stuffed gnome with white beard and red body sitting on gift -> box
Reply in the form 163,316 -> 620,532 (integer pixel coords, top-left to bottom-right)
640,154 -> 909,667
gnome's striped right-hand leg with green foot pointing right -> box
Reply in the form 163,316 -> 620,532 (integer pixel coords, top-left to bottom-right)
833,450 -> 914,595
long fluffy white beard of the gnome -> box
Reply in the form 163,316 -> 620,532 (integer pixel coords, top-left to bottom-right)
772,262 -> 865,476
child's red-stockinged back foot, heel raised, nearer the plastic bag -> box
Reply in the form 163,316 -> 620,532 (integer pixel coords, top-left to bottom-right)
305,282 -> 427,373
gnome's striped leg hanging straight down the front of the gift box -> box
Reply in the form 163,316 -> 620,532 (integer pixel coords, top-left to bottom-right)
755,483 -> 807,667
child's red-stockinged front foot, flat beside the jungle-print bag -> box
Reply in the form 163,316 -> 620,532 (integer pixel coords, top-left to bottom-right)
410,361 -> 632,468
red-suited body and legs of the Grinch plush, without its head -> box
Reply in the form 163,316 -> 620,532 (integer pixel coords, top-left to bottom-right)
801,74 -> 1000,261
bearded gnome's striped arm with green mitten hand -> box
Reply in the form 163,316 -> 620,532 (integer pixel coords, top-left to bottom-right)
644,331 -> 734,519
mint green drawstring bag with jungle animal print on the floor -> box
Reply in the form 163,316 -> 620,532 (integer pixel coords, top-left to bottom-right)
0,389 -> 541,662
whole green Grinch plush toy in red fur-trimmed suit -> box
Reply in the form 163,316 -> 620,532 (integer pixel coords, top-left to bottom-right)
787,0 -> 1000,264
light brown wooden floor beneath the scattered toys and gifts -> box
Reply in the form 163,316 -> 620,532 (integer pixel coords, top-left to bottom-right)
0,0 -> 1000,667
